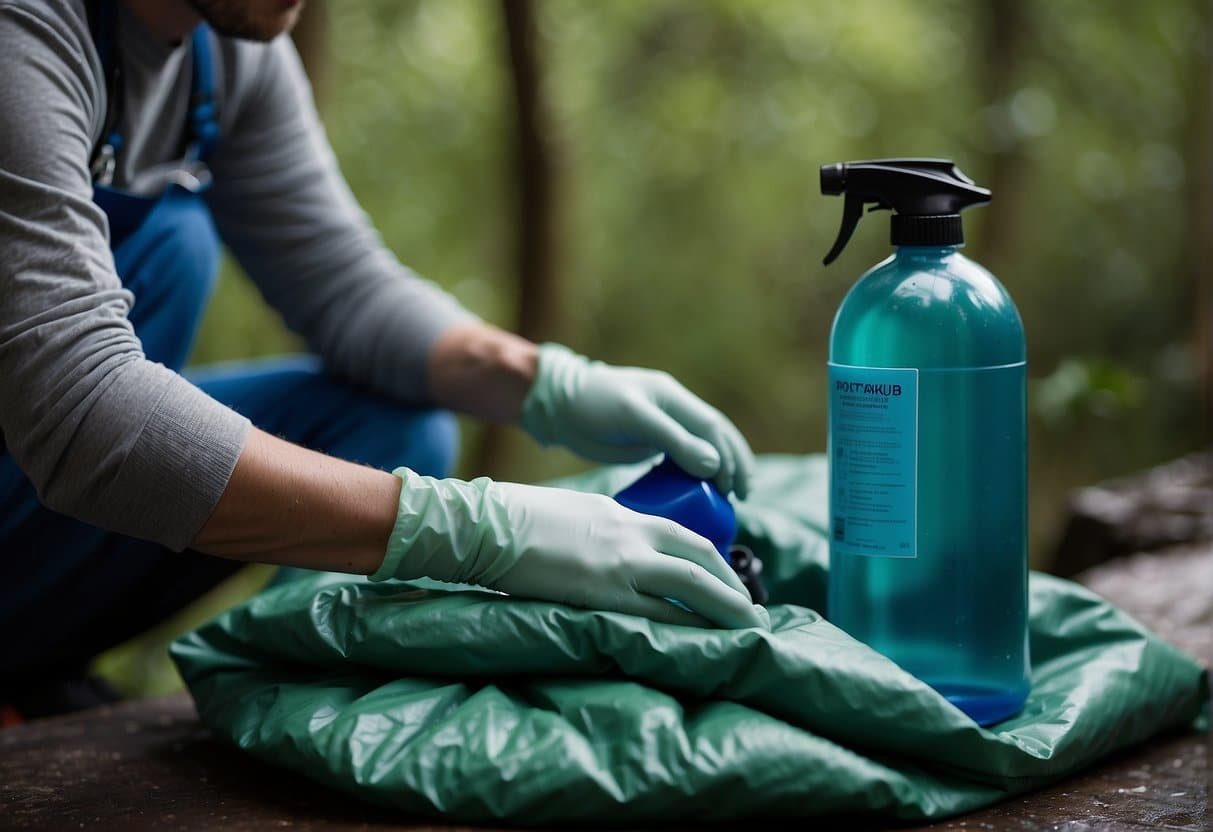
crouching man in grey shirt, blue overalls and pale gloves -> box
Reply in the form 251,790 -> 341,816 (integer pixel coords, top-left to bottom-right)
0,0 -> 767,714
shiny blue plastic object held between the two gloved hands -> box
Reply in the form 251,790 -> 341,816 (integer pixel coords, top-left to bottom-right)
615,458 -> 738,564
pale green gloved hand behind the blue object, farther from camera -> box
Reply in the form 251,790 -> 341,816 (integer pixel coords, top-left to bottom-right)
522,343 -> 753,498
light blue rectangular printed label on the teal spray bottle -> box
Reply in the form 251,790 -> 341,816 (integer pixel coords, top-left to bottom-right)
830,363 -> 918,558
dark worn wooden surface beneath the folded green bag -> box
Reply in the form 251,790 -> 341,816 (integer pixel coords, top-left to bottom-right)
0,547 -> 1213,832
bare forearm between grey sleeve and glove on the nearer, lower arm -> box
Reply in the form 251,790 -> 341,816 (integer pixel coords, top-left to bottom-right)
193,429 -> 400,575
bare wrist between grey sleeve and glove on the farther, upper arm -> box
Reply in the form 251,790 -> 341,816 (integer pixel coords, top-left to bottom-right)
427,323 -> 537,422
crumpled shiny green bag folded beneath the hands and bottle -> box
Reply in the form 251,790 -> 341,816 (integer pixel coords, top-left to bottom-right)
172,456 -> 1207,825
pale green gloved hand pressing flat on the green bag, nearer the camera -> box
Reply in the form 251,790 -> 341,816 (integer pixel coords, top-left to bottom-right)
371,468 -> 770,629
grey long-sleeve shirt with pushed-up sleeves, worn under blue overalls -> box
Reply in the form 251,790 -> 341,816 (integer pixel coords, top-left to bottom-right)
0,0 -> 471,549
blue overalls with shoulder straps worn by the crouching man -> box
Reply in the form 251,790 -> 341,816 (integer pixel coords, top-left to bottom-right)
0,13 -> 456,702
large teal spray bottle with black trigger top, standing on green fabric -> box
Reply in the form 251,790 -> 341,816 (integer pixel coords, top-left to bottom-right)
821,159 -> 1030,725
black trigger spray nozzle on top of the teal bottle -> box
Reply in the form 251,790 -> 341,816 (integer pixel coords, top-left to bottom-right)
821,159 -> 990,266
